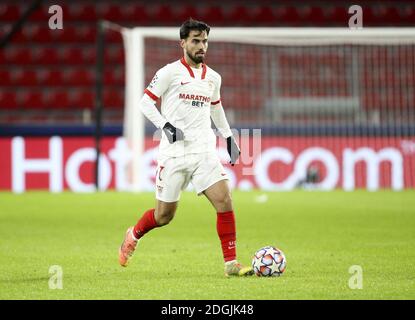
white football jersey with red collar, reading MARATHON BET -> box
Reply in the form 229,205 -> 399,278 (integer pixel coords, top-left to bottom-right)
144,58 -> 221,157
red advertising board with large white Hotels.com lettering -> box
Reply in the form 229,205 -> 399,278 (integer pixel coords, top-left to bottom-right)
0,137 -> 415,192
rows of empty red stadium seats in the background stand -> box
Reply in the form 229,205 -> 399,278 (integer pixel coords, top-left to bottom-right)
0,0 -> 415,123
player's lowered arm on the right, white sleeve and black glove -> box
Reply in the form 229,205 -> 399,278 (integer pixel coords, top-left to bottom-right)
210,79 -> 241,166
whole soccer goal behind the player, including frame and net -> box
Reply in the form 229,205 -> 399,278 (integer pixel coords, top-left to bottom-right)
116,27 -> 415,190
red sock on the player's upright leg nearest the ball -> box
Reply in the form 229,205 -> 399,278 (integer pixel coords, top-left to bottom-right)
216,211 -> 236,262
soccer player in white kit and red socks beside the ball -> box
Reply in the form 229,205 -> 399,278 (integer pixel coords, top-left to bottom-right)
119,19 -> 253,276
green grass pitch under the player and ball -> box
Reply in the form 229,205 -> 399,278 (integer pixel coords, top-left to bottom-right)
0,191 -> 415,300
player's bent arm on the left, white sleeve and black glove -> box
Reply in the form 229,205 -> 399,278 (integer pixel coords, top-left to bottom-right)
140,66 -> 183,143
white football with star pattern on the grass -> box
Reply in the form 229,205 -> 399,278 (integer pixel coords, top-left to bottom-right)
252,246 -> 287,277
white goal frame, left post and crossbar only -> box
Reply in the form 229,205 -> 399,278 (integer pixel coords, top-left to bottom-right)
111,26 -> 415,192
